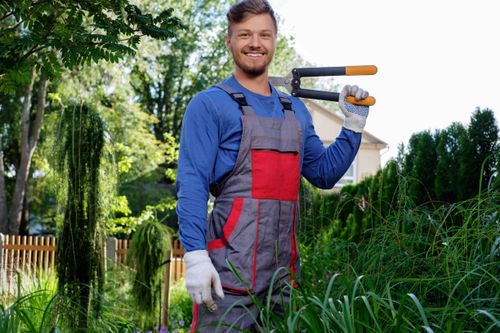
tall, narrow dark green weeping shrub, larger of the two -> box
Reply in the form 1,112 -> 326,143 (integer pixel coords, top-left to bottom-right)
55,105 -> 104,329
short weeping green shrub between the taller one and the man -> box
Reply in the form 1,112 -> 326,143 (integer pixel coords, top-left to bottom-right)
128,218 -> 172,323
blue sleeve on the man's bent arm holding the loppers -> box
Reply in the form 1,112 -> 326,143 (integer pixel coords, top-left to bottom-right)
302,113 -> 361,189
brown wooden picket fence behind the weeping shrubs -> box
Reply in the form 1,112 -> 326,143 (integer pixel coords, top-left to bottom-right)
0,234 -> 185,289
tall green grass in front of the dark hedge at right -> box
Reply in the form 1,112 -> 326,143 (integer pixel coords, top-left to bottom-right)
294,183 -> 500,332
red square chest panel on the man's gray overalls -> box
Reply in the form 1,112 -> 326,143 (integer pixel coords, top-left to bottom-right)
252,150 -> 300,201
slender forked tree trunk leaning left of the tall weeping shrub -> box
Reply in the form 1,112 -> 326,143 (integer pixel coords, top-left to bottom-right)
9,69 -> 47,235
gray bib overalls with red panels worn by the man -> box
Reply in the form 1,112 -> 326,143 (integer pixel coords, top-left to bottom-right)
191,84 -> 302,332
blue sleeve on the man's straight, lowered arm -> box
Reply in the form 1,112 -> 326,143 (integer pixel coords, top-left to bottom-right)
176,95 -> 219,251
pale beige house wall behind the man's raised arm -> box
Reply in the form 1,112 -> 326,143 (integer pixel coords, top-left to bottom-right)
303,99 -> 388,187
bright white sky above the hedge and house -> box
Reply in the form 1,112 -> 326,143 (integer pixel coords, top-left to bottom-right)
269,0 -> 500,165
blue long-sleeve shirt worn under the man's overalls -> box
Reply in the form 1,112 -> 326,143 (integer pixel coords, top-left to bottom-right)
176,76 -> 361,251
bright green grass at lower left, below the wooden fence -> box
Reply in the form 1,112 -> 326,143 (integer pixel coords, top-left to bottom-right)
0,267 -> 192,333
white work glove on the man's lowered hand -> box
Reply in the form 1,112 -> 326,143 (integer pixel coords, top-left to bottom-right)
184,250 -> 224,311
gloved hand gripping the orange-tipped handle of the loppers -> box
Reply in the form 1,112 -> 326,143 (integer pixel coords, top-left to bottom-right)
339,85 -> 369,133
